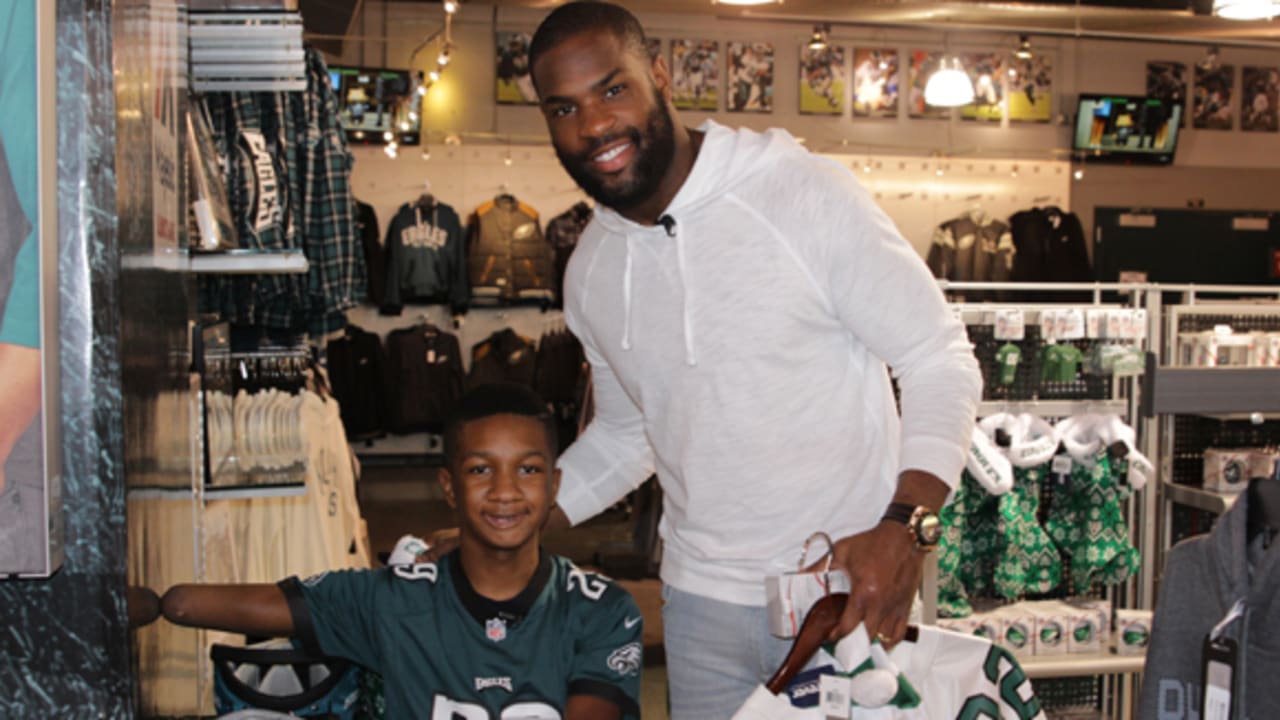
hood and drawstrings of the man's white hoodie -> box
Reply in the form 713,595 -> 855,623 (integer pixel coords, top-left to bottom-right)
595,120 -> 799,366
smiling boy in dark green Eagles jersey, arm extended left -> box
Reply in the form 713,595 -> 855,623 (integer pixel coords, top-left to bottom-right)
163,386 -> 643,720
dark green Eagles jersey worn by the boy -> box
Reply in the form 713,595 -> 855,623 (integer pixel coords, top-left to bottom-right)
280,552 -> 643,720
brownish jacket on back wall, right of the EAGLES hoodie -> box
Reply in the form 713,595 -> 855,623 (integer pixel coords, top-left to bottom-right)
467,195 -> 556,302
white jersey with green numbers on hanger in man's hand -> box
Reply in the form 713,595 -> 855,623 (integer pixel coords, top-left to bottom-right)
733,625 -> 1044,720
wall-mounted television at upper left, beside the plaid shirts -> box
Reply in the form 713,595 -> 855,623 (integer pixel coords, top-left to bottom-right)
329,65 -> 422,145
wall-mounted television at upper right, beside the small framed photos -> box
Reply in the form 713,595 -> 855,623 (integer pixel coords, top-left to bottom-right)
1071,94 -> 1183,165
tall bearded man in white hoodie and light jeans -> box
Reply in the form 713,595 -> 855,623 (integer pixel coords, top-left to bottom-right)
471,3 -> 982,720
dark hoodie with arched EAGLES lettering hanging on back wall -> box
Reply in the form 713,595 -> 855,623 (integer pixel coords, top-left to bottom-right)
381,199 -> 467,315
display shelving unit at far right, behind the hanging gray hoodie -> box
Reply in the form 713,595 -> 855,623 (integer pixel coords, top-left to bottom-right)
1142,286 -> 1280,584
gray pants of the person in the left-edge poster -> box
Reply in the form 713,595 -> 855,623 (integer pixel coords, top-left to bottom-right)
0,414 -> 49,575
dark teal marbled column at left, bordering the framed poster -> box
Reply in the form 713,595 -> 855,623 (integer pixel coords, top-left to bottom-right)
0,0 -> 132,717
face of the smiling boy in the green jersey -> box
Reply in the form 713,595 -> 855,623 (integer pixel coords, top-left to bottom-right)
440,415 -> 559,551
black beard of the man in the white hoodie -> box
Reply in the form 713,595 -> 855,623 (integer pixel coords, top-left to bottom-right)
556,90 -> 676,210
